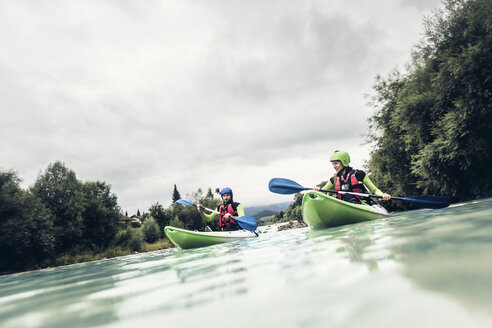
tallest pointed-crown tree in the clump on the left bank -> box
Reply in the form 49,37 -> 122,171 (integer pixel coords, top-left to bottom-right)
31,161 -> 84,252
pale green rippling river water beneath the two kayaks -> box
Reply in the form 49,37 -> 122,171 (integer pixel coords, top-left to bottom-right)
0,199 -> 492,328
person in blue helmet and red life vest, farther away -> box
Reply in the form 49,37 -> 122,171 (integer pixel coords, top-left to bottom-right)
196,188 -> 244,231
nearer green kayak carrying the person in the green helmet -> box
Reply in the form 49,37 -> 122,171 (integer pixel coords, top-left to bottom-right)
302,191 -> 388,229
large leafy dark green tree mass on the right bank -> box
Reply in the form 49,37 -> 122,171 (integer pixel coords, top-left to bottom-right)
368,0 -> 492,205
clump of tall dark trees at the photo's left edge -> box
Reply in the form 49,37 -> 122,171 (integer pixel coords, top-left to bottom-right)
0,162 -> 120,270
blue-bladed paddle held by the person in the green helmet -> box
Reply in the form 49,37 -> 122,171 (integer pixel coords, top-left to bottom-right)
268,178 -> 450,208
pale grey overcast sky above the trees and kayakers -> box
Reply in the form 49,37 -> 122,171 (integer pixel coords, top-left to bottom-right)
0,0 -> 440,214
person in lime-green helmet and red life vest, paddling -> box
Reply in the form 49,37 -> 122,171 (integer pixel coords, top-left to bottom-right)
313,150 -> 391,204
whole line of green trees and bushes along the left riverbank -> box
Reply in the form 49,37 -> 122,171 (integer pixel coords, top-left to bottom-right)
0,162 -> 219,272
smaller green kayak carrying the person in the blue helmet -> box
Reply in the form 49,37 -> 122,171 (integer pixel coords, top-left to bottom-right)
164,226 -> 256,249
